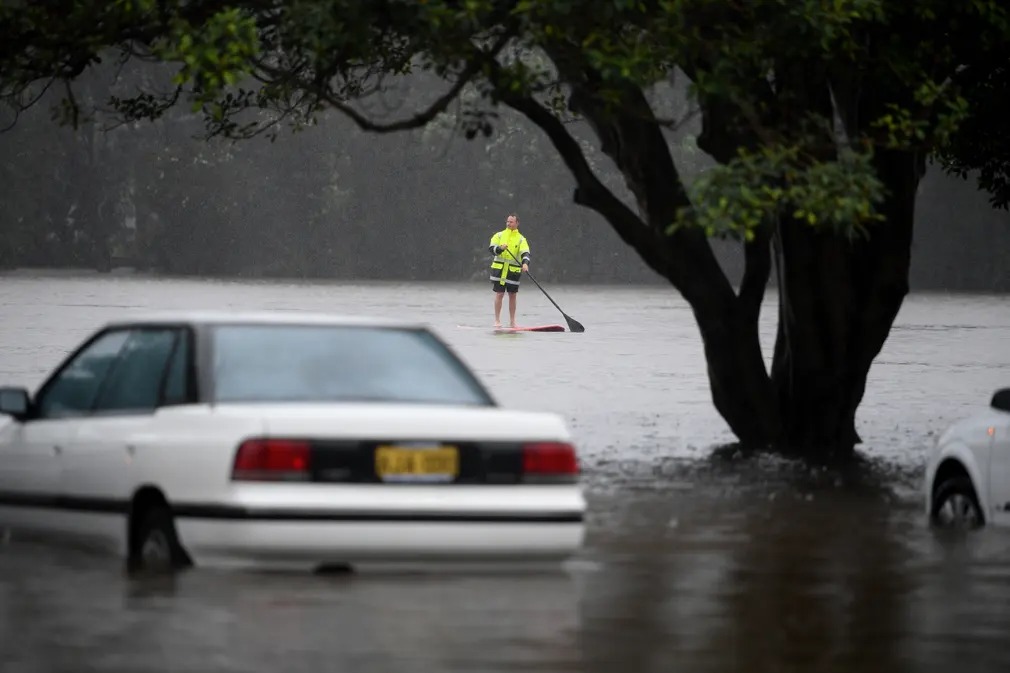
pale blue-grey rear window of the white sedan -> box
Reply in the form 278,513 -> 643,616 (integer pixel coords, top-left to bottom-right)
212,324 -> 494,406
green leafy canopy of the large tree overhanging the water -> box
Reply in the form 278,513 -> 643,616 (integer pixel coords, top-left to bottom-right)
0,0 -> 1007,228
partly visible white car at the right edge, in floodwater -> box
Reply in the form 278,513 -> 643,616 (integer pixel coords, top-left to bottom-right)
925,388 -> 1010,528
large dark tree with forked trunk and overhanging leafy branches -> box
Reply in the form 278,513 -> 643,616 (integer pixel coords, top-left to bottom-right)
0,0 -> 1010,458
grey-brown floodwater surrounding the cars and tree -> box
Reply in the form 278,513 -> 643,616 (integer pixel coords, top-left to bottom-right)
0,275 -> 1010,673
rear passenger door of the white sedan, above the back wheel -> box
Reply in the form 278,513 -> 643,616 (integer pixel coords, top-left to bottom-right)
60,326 -> 189,553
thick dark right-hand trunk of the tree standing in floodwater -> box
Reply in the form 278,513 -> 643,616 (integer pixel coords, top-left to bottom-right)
772,152 -> 923,460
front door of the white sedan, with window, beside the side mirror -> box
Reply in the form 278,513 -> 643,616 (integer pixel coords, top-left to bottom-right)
0,329 -> 128,533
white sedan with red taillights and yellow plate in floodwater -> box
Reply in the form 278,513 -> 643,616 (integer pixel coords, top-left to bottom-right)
0,312 -> 585,571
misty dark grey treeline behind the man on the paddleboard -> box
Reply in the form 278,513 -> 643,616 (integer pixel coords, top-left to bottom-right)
0,66 -> 1010,291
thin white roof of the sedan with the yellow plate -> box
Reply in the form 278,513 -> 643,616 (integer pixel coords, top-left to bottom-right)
106,310 -> 427,329
